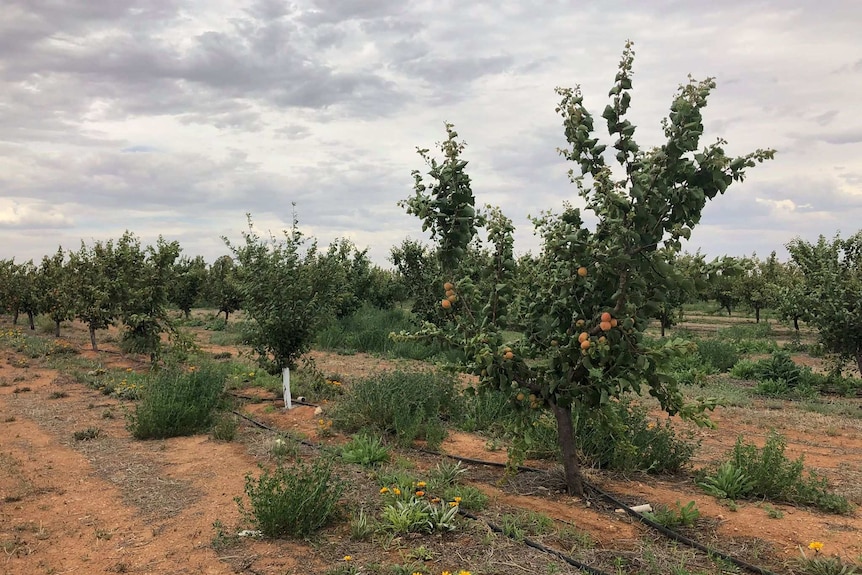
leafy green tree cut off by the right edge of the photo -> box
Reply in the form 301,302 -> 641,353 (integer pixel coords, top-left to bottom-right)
787,231 -> 862,372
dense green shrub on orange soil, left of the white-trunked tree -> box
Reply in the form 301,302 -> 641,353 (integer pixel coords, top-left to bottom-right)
128,364 -> 225,439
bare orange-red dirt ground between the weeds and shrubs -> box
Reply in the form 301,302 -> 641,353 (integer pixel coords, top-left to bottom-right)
0,319 -> 862,575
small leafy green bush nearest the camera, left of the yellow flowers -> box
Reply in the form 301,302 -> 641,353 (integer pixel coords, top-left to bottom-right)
235,461 -> 345,538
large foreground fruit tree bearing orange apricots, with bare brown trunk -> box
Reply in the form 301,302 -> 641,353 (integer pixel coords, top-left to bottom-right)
402,43 -> 774,495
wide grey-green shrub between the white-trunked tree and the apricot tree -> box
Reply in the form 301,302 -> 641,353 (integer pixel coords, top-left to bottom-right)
332,371 -> 463,449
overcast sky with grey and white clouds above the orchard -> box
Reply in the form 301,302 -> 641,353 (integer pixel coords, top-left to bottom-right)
0,0 -> 862,264
